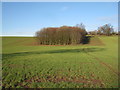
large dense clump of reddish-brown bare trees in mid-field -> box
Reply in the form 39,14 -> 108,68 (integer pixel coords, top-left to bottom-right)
36,24 -> 87,45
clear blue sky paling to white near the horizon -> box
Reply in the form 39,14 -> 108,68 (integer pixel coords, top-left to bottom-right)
2,2 -> 118,36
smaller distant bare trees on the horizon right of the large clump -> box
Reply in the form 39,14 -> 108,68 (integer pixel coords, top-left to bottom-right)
88,24 -> 119,36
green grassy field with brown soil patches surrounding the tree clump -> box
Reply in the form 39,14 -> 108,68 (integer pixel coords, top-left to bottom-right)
2,36 -> 118,88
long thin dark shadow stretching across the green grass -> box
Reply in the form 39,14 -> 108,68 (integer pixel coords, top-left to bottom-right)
2,48 -> 105,60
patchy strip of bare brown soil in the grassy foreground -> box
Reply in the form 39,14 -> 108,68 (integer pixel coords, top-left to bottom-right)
18,75 -> 104,88
